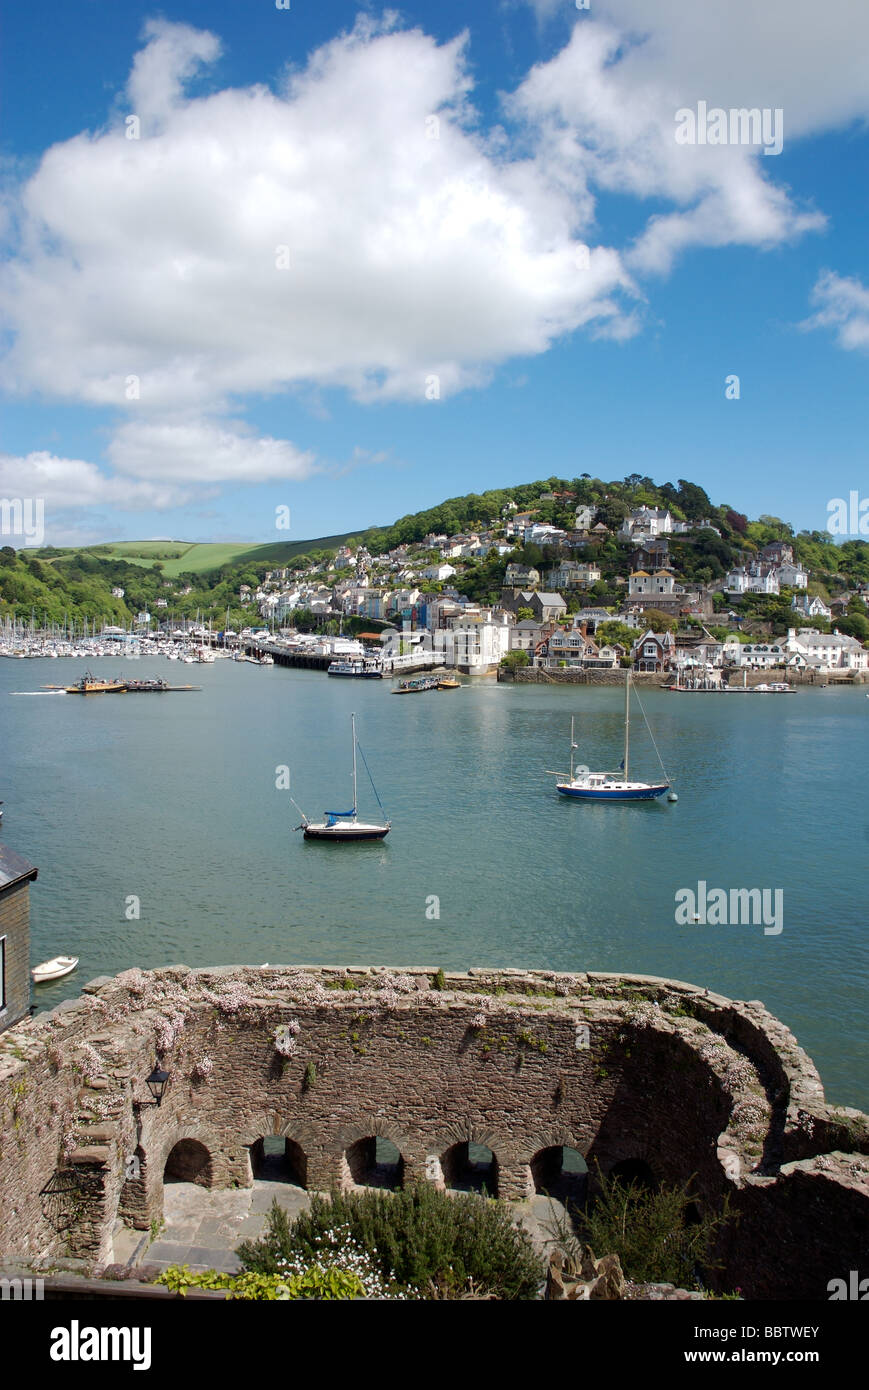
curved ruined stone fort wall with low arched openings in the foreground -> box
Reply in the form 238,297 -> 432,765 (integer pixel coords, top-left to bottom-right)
0,966 -> 869,1300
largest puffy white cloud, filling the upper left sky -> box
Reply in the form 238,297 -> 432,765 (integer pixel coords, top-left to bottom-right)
0,21 -> 631,413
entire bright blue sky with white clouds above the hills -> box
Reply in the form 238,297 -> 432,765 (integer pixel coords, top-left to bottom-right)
0,0 -> 869,543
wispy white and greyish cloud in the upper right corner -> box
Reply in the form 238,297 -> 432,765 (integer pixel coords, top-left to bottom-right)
509,0 -> 834,274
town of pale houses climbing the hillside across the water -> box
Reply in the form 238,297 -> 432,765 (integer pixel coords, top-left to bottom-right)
239,492 -> 869,674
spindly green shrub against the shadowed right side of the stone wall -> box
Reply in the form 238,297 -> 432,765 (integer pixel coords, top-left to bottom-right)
577,1168 -> 734,1289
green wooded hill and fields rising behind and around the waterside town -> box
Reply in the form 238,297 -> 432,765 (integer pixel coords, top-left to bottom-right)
0,474 -> 869,630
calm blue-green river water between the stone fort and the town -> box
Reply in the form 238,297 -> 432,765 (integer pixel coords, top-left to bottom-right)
0,660 -> 869,1108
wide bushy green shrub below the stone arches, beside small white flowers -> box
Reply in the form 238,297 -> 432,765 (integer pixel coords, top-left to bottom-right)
236,1183 -> 542,1300
